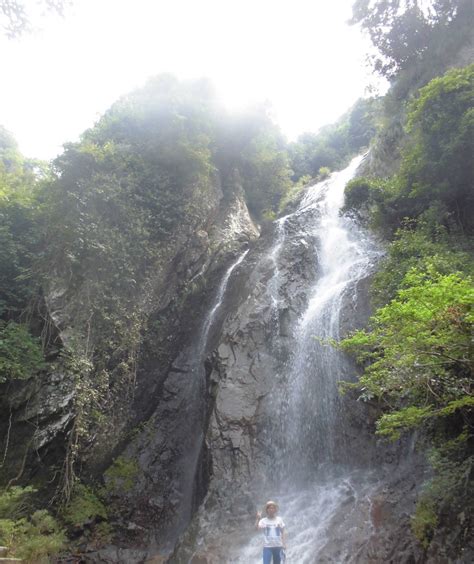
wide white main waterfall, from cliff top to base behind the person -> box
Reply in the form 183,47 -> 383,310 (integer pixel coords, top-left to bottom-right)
232,157 -> 379,564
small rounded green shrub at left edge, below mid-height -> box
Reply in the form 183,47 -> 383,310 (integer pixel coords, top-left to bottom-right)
0,321 -> 45,384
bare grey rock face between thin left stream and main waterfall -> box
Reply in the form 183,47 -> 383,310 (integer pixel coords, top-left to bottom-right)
200,220 -> 315,490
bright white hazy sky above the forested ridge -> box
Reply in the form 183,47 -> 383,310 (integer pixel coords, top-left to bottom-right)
0,0 -> 386,159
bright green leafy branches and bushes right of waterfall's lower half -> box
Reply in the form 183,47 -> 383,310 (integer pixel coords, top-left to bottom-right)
340,238 -> 474,548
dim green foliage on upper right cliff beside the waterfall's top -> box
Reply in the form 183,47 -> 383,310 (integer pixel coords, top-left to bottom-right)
346,65 -> 474,236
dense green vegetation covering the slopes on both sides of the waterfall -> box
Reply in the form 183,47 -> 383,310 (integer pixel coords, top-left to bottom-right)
0,0 -> 474,562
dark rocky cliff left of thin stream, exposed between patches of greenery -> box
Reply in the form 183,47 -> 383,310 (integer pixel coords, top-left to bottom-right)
0,167 -> 258,552
